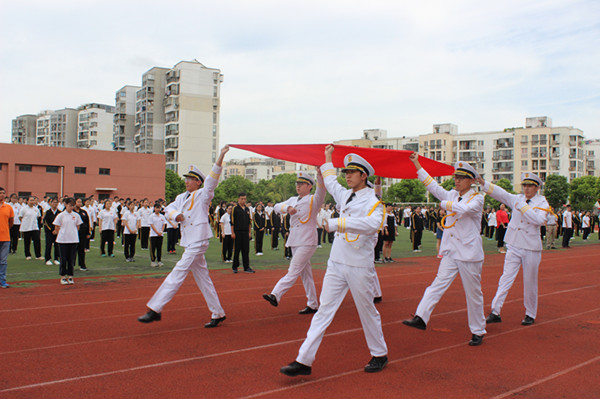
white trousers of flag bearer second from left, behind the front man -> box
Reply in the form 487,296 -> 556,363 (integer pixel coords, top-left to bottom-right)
271,245 -> 319,309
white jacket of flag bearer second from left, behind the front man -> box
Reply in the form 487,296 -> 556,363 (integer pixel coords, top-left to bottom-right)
273,182 -> 327,247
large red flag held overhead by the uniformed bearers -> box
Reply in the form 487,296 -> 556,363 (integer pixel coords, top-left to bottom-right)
230,144 -> 454,179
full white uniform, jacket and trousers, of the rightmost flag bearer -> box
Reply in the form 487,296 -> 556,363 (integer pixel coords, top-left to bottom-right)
483,182 -> 550,319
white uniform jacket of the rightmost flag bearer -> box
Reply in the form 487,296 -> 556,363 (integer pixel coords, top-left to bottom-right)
483,182 -> 550,251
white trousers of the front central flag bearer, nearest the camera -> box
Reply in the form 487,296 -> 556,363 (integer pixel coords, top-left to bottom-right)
296,260 -> 387,366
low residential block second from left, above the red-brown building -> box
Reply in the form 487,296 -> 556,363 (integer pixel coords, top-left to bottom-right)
35,108 -> 78,147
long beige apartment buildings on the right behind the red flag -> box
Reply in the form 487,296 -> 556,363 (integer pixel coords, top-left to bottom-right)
335,116 -> 600,187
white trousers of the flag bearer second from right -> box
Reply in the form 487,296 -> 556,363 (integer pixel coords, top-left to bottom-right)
415,255 -> 486,335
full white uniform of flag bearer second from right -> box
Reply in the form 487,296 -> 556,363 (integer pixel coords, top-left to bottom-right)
415,168 -> 486,335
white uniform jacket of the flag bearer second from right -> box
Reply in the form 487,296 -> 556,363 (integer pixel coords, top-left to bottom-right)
417,168 -> 484,262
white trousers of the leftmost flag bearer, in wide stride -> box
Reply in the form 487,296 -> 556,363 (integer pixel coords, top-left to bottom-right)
147,240 -> 225,319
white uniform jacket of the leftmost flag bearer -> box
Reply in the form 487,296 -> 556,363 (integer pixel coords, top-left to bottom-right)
165,165 -> 221,248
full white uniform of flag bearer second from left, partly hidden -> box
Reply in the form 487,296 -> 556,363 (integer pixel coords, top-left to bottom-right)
271,182 -> 327,309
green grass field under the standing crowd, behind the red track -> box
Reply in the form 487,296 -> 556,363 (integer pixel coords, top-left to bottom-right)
7,228 -> 598,287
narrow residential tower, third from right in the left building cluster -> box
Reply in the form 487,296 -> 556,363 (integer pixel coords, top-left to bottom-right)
113,86 -> 140,152
